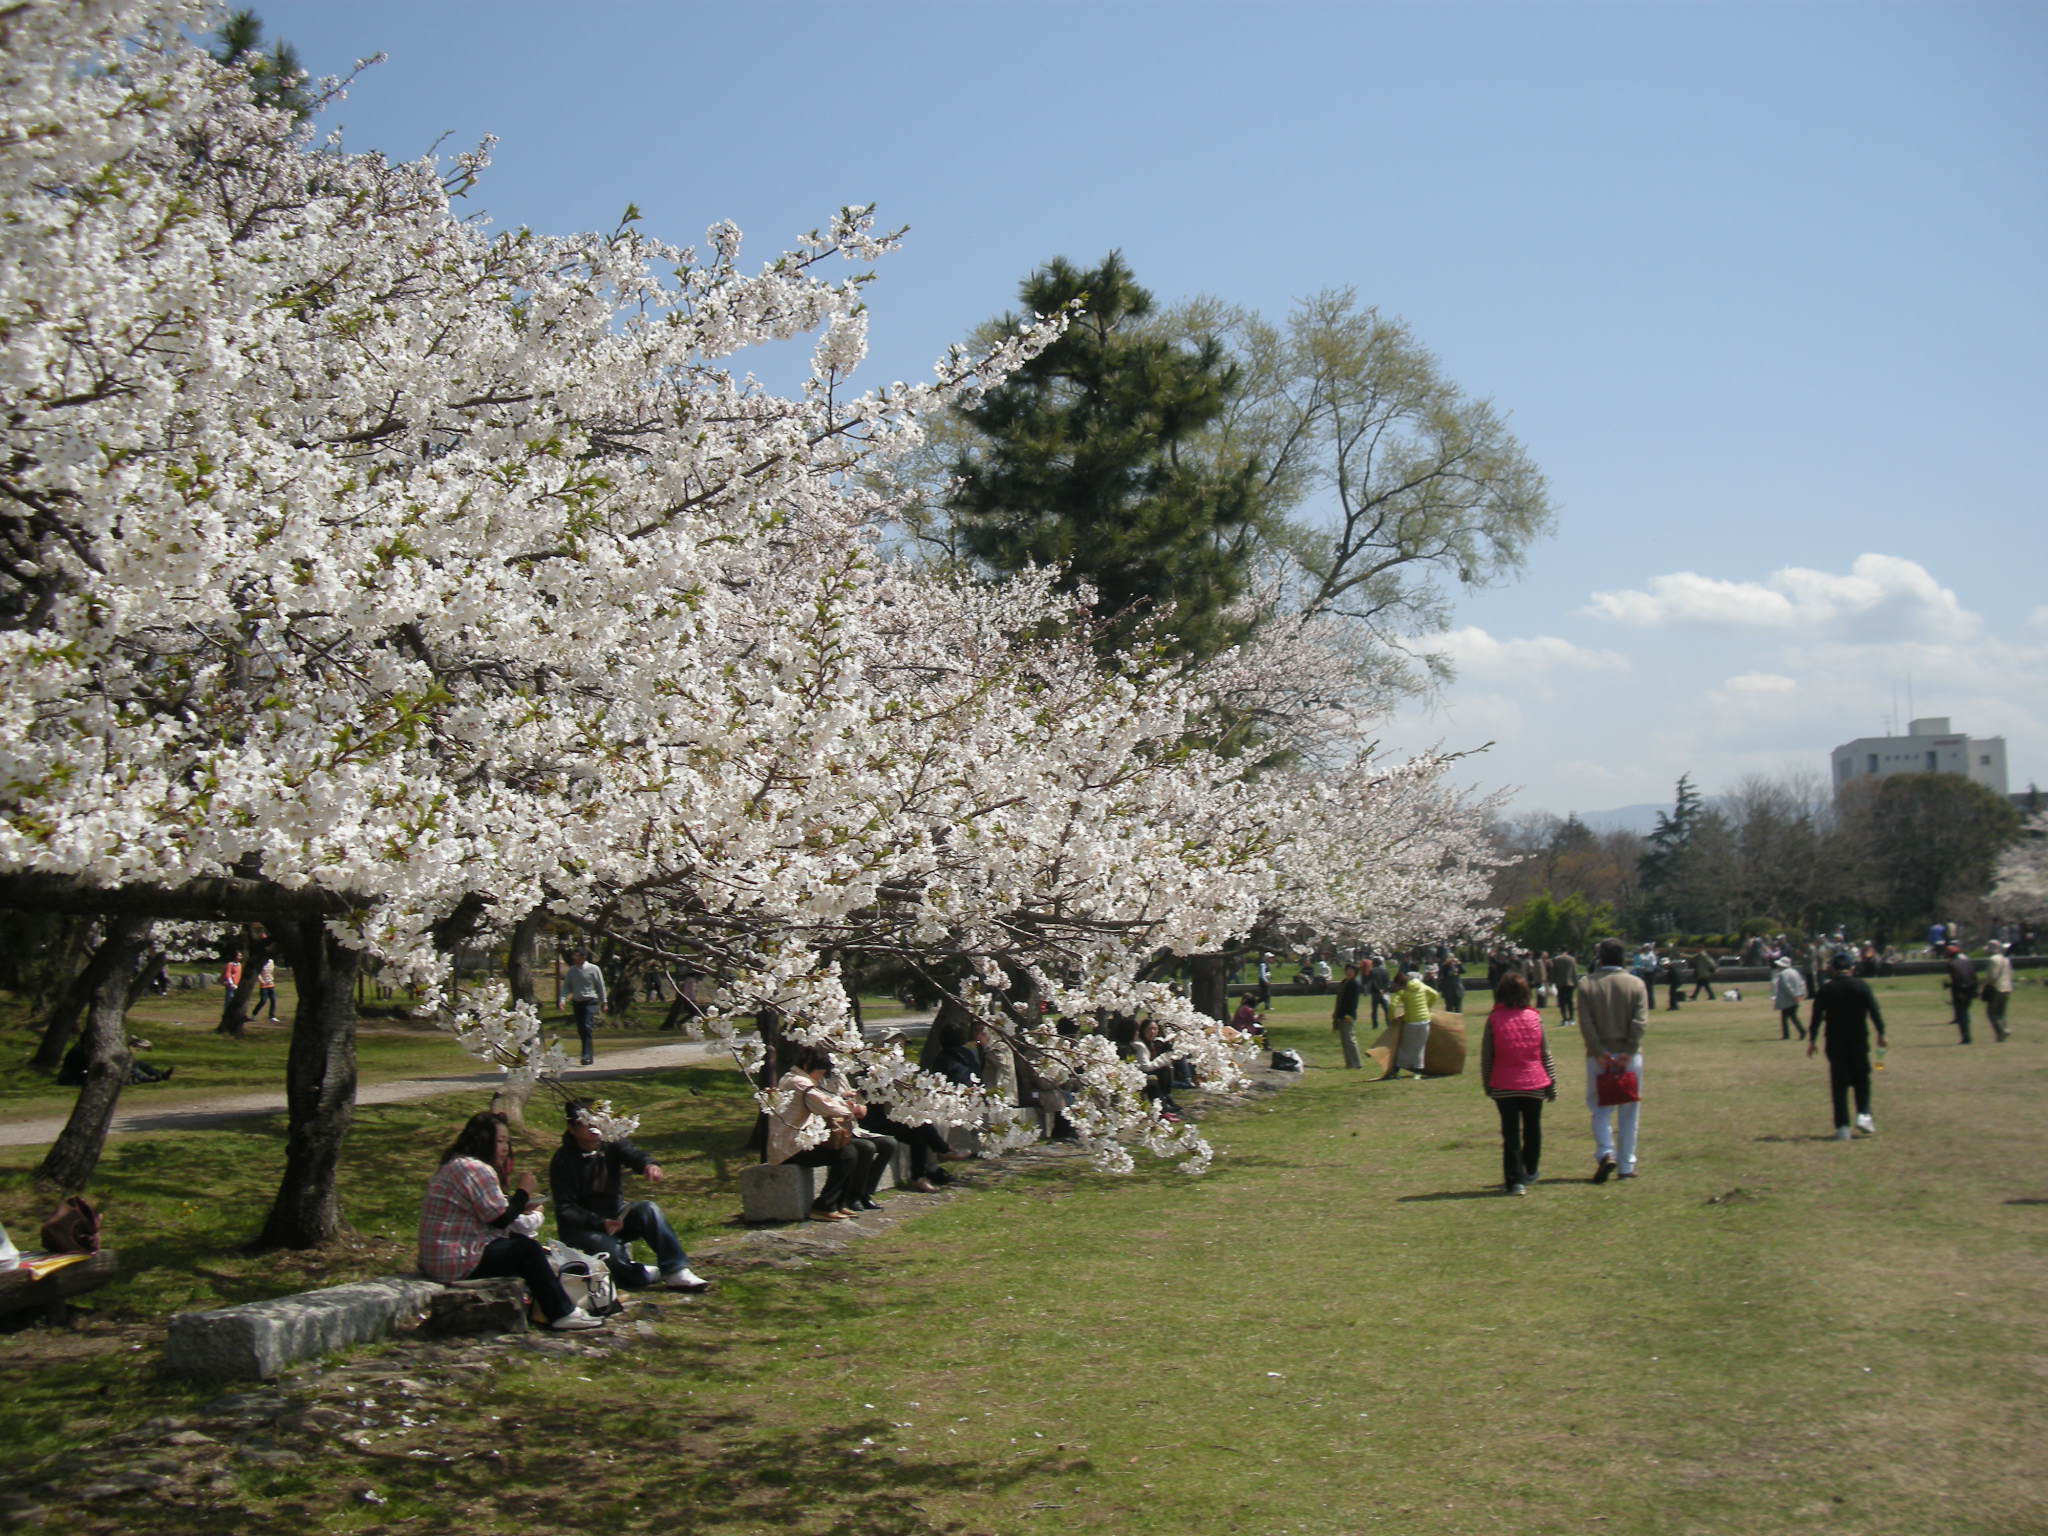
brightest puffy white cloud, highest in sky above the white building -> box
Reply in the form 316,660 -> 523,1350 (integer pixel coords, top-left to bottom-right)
1585,555 -> 1980,641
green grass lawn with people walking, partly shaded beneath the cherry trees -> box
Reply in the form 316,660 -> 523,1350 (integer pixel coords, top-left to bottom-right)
0,979 -> 2048,1536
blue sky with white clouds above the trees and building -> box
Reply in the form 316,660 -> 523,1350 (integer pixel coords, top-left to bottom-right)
258,0 -> 2048,813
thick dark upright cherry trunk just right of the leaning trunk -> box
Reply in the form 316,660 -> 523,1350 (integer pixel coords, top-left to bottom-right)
256,918 -> 362,1247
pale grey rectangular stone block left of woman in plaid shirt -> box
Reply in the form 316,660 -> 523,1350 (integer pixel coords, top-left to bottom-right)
164,1274 -> 442,1380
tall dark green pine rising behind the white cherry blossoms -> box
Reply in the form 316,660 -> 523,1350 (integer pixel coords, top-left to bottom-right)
950,252 -> 1262,655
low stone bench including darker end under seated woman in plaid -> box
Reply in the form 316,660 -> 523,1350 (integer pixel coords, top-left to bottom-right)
164,1274 -> 526,1382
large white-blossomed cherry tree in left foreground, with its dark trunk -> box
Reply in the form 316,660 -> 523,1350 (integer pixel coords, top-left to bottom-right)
0,0 -> 1507,1243
